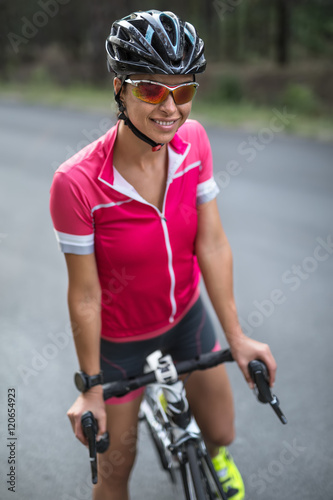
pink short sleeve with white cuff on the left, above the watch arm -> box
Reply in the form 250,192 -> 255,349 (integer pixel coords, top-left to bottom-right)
50,172 -> 94,255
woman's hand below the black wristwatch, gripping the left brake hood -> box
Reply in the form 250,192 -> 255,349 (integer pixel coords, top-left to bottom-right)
67,386 -> 106,446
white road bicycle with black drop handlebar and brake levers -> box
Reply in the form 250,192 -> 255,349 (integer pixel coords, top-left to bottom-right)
82,349 -> 287,500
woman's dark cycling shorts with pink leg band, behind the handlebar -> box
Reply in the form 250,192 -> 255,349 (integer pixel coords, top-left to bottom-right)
101,297 -> 219,404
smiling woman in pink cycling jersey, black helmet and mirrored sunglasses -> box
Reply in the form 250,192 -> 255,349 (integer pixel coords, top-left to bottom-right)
51,10 -> 276,500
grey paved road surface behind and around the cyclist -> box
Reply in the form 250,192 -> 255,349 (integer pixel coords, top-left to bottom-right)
0,101 -> 333,500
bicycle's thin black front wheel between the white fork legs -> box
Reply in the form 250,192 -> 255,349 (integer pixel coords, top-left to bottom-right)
181,441 -> 207,500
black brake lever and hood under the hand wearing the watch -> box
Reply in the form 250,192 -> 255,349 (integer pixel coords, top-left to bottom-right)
81,411 -> 110,484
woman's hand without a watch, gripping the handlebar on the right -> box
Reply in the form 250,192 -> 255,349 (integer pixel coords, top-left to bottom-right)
230,334 -> 277,389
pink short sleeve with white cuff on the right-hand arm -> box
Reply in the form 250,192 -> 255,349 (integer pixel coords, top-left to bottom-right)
193,123 -> 220,205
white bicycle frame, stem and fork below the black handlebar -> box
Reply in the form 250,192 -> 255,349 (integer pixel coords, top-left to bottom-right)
140,351 -> 226,500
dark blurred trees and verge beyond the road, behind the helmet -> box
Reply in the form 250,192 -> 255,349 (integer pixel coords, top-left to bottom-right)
0,0 -> 333,111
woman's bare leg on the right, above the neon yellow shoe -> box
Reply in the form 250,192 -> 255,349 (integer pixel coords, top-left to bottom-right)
185,365 -> 234,446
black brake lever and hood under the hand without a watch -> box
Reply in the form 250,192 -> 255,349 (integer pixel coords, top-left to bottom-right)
248,359 -> 288,424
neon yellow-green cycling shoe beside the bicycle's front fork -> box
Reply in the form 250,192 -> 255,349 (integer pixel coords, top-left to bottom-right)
212,447 -> 245,500
